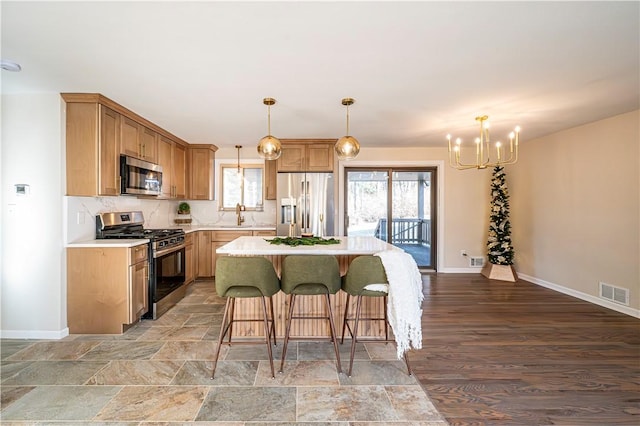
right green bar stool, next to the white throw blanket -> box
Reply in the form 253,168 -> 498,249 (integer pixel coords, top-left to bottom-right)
340,256 -> 412,376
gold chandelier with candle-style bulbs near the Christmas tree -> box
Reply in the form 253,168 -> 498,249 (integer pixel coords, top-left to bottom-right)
447,115 -> 520,170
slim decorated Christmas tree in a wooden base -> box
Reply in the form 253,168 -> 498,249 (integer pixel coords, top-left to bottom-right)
482,165 -> 517,281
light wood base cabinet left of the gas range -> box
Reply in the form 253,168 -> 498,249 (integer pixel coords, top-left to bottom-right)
67,243 -> 149,334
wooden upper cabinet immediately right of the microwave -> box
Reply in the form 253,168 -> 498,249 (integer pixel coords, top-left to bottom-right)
158,136 -> 187,199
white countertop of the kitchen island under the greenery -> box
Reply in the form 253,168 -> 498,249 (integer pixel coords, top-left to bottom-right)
216,237 -> 400,256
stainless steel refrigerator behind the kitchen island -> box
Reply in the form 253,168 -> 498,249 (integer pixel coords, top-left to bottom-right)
276,173 -> 336,237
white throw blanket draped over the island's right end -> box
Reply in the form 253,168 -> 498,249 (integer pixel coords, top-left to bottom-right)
375,250 -> 424,359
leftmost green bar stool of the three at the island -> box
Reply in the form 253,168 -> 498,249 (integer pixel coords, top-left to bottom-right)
211,256 -> 280,379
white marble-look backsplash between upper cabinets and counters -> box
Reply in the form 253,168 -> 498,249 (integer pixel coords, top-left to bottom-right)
64,196 -> 276,243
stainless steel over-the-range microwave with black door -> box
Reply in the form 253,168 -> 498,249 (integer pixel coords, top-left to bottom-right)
120,155 -> 162,195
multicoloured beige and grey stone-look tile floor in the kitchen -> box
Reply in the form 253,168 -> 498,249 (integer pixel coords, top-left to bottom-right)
0,281 -> 447,426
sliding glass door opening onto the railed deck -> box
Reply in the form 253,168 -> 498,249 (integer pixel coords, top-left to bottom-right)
345,167 -> 437,269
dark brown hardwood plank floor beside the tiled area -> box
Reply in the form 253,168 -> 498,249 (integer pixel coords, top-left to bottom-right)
410,274 -> 640,426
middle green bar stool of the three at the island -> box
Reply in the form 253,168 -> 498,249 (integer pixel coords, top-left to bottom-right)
280,255 -> 342,373
